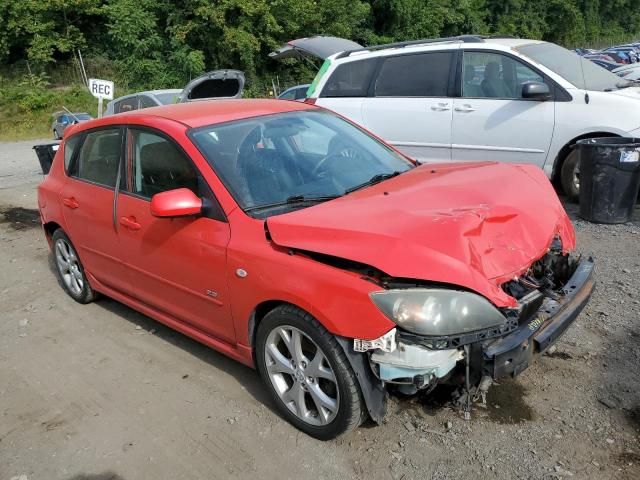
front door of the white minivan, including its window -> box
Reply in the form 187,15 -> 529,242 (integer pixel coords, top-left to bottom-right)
452,50 -> 555,167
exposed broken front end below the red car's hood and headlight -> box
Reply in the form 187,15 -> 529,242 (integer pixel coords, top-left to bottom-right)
354,246 -> 593,417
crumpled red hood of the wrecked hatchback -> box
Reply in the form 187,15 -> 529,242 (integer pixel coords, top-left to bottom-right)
267,163 -> 575,307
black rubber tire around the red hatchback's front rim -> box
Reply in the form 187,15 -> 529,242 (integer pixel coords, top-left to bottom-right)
255,305 -> 367,440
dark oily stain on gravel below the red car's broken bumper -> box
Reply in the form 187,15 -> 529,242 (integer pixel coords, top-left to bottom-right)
487,380 -> 535,424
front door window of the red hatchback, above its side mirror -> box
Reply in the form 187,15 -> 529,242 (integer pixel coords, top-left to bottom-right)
129,129 -> 200,198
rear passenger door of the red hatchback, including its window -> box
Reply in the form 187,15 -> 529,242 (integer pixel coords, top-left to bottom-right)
60,127 -> 129,292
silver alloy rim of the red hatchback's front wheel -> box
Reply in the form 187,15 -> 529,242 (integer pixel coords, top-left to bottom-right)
264,325 -> 340,426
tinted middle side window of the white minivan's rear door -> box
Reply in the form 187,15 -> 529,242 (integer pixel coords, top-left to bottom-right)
375,52 -> 453,97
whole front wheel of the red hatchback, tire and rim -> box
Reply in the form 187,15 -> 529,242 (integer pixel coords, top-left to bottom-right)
256,305 -> 366,440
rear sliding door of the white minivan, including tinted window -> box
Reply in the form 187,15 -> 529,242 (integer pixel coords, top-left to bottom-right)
362,50 -> 456,162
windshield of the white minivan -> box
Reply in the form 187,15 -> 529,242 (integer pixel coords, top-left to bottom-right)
516,43 -> 624,91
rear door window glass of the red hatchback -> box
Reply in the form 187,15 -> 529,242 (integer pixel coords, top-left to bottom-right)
73,128 -> 122,187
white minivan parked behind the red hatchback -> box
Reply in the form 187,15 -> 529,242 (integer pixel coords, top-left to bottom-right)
282,36 -> 640,197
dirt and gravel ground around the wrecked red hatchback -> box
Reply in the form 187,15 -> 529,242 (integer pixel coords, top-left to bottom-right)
0,141 -> 640,480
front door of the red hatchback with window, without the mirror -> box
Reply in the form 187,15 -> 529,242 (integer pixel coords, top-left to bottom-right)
117,128 -> 235,342
